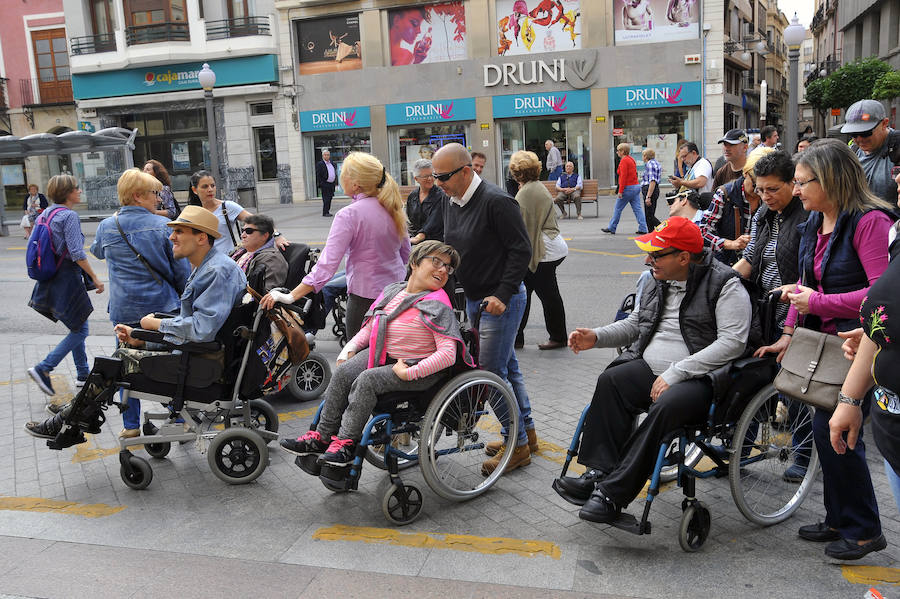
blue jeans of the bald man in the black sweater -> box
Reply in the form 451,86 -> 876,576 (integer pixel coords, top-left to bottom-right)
466,284 -> 534,447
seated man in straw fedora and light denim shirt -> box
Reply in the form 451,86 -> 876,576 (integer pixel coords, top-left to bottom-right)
25,206 -> 247,449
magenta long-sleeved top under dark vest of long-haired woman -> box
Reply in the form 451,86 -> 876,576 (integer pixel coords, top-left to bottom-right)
784,210 -> 893,333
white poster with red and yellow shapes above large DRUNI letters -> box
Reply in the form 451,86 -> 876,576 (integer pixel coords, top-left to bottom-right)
496,0 -> 584,56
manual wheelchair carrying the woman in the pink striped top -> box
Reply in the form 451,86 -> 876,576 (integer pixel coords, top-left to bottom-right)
295,304 -> 519,525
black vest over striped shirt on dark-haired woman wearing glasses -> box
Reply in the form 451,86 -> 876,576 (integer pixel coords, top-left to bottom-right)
750,197 -> 809,291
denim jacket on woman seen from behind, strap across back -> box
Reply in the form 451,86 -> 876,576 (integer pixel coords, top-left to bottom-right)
91,206 -> 191,324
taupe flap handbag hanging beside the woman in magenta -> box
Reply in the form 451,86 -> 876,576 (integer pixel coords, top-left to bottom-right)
774,327 -> 850,412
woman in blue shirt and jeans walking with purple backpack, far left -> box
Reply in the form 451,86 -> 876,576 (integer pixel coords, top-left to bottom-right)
28,175 -> 103,395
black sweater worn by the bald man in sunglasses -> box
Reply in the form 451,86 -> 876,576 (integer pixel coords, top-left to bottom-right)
444,181 -> 531,304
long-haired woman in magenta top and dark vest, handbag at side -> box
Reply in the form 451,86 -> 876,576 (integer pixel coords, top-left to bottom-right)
757,139 -> 894,560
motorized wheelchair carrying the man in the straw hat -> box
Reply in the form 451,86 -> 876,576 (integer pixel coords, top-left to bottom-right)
47,302 -> 279,489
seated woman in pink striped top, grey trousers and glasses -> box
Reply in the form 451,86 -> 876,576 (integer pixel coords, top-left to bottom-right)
280,240 -> 474,468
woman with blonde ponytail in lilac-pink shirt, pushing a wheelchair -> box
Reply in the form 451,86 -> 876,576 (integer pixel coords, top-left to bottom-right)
261,152 -> 411,338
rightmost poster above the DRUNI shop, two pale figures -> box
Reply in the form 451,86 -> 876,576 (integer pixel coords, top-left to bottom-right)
612,0 -> 700,46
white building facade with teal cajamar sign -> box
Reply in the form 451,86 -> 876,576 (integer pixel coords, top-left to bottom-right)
63,0 -> 293,207
